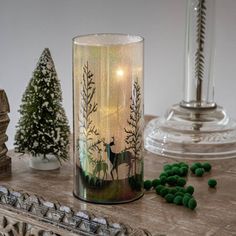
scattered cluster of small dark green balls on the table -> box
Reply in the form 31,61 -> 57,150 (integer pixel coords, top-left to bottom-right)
144,162 -> 217,210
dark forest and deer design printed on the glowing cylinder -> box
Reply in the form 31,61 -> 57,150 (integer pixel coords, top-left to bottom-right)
76,62 -> 143,199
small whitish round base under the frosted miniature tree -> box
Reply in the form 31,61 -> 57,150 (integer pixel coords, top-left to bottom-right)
29,155 -> 60,170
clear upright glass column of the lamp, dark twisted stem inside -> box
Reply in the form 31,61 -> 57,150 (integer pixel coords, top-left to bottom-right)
181,0 -> 216,108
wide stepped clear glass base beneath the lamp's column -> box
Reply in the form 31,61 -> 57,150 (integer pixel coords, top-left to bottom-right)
144,104 -> 236,160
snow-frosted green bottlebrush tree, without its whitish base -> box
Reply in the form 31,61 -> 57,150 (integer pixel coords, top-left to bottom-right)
15,48 -> 70,162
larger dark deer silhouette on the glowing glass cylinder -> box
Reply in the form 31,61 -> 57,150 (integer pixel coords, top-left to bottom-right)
105,137 -> 133,180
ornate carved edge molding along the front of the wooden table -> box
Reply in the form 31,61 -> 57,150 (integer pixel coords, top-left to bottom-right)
0,186 -> 151,236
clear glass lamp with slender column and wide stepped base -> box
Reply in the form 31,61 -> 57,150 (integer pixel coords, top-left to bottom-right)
145,0 -> 236,160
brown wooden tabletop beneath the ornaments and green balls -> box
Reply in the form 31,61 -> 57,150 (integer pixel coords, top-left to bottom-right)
0,116 -> 236,235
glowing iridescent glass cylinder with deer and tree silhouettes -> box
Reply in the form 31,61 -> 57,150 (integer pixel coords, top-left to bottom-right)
73,34 -> 144,204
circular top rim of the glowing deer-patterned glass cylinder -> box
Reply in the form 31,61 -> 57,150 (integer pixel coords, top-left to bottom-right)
72,33 -> 144,46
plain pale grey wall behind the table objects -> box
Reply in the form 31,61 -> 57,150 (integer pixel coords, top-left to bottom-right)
0,0 -> 236,148
